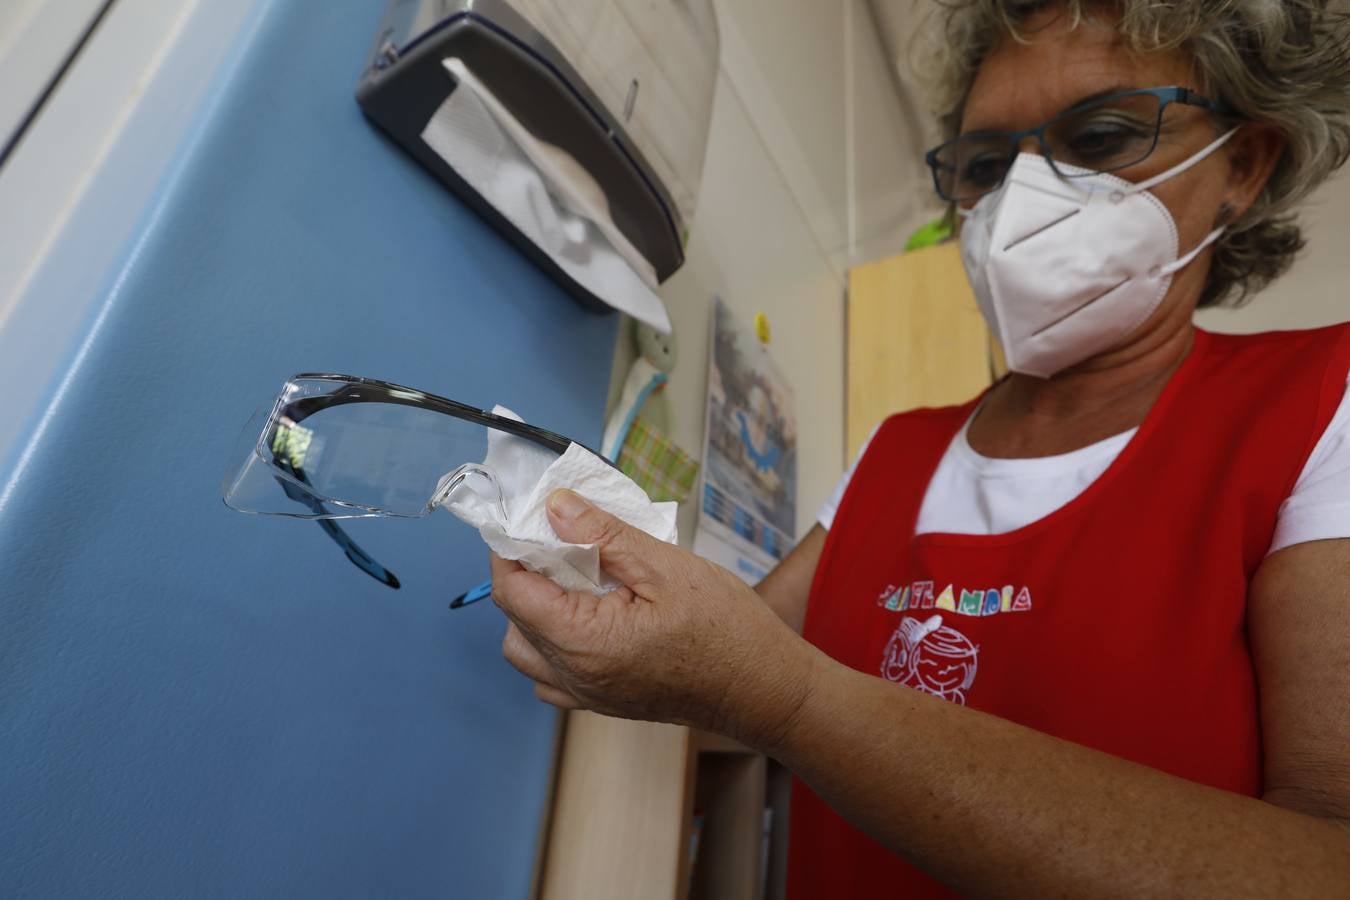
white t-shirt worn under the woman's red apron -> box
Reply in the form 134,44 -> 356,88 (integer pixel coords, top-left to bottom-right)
817,372 -> 1350,553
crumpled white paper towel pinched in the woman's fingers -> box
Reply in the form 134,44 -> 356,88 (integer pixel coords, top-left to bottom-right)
444,406 -> 679,594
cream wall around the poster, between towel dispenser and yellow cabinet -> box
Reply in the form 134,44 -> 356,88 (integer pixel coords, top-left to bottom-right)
614,0 -> 918,541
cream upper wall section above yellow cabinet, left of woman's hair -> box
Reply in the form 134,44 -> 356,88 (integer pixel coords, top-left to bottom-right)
718,0 -> 933,279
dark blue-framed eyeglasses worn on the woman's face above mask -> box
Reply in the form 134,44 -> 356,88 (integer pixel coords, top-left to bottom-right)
923,88 -> 1233,202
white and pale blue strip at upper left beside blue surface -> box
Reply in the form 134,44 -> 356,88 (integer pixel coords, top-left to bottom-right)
0,0 -> 261,477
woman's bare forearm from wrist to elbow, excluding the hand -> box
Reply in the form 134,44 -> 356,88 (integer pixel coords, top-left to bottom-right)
763,652 -> 1350,897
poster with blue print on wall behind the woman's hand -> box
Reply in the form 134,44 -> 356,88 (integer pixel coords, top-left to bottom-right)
694,300 -> 797,584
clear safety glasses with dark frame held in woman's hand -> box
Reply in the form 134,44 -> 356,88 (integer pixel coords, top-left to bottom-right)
221,374 -> 607,609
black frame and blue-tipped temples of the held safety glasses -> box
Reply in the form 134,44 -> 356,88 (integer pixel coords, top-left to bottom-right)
254,372 -> 618,609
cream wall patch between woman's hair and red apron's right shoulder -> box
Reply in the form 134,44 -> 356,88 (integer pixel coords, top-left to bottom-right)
1196,167 -> 1350,332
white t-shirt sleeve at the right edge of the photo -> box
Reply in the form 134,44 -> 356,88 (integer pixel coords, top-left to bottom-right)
1270,369 -> 1350,553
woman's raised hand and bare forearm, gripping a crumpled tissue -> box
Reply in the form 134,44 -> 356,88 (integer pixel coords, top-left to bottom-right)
493,495 -> 1350,897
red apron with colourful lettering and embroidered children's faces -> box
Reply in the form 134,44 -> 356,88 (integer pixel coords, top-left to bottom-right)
788,325 -> 1350,900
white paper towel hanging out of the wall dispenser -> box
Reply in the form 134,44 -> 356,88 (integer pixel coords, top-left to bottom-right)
421,58 -> 671,335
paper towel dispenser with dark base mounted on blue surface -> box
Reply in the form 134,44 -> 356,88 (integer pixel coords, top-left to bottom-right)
356,0 -> 718,317
